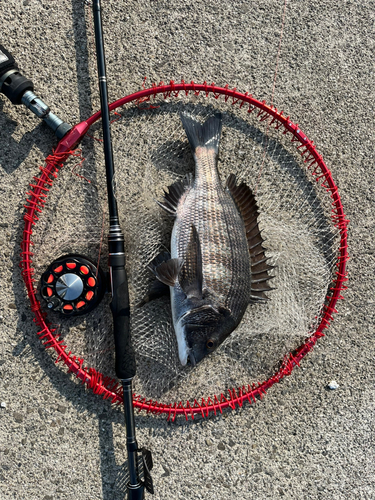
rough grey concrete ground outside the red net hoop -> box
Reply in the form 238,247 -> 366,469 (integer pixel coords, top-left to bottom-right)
0,0 -> 375,500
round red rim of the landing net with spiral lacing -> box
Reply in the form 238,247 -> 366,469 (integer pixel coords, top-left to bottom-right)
20,81 -> 348,420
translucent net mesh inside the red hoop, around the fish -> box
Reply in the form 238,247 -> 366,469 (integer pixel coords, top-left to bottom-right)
29,94 -> 340,403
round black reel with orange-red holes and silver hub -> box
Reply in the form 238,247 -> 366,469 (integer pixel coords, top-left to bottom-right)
40,254 -> 106,316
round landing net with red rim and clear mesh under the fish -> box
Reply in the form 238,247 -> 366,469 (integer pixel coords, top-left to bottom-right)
21,82 -> 347,418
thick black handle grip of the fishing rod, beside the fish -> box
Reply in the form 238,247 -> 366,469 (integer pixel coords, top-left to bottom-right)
111,267 -> 136,380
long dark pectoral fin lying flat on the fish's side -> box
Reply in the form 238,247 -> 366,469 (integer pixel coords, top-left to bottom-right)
179,225 -> 203,299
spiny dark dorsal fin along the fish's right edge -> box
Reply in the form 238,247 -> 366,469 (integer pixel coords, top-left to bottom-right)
226,174 -> 274,302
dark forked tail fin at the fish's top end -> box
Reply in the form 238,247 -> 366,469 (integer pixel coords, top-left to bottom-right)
180,113 -> 222,154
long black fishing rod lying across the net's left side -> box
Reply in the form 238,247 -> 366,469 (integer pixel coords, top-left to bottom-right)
93,0 -> 153,500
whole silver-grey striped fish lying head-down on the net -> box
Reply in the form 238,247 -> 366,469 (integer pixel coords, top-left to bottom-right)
142,112 -> 273,366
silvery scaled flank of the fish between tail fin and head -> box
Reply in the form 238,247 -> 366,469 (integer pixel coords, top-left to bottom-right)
172,148 -> 251,315
